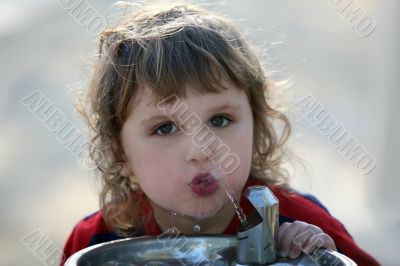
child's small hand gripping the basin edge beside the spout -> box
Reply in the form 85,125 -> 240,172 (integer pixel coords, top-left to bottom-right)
278,221 -> 336,259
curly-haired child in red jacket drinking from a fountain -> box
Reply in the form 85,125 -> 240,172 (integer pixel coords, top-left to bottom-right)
63,1 -> 378,265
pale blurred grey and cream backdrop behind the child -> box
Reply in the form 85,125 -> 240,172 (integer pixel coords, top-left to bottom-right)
0,0 -> 400,265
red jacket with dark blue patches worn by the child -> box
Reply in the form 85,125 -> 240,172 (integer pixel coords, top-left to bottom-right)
61,178 -> 379,266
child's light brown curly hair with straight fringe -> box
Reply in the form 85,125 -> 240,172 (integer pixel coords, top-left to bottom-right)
79,1 -> 291,234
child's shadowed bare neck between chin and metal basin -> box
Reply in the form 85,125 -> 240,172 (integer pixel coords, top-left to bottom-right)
149,200 -> 235,235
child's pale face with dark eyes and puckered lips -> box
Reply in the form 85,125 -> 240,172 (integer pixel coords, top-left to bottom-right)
121,84 -> 253,218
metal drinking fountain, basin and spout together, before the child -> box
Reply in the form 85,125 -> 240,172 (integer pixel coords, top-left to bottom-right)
65,186 -> 356,266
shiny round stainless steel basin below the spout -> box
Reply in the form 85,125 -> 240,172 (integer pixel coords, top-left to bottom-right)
65,235 -> 356,266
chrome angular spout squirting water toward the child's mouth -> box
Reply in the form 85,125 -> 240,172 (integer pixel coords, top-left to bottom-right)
235,186 -> 279,266
